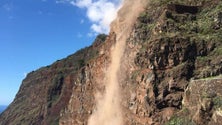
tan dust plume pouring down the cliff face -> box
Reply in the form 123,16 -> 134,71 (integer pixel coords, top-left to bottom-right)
88,0 -> 148,125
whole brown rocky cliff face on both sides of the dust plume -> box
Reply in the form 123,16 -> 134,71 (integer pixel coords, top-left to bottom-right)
0,0 -> 222,125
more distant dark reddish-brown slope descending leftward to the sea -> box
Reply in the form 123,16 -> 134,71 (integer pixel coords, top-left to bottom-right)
0,35 -> 106,125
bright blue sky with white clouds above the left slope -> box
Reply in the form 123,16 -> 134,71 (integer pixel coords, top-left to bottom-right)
0,0 -> 122,105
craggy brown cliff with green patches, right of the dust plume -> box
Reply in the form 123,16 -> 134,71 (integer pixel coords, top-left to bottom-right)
121,0 -> 222,125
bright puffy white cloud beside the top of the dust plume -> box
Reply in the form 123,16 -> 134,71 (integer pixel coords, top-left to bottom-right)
56,0 -> 122,34
